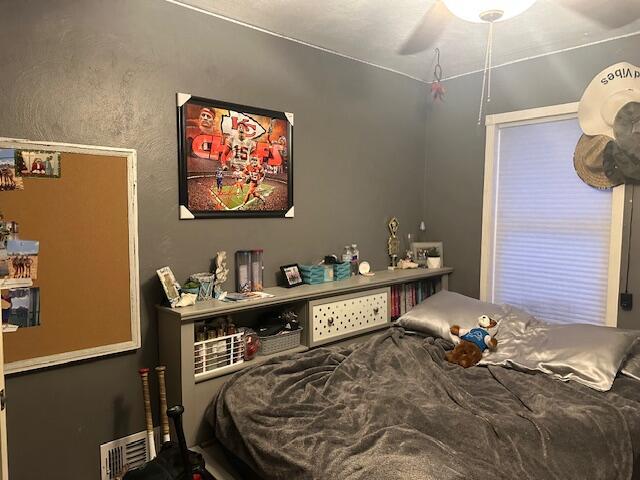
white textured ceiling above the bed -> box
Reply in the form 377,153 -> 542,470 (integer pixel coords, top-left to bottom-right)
170,0 -> 640,81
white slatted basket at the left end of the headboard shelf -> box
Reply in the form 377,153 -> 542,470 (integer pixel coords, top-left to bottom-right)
193,332 -> 245,378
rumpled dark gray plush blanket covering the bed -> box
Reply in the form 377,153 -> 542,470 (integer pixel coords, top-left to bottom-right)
207,328 -> 640,480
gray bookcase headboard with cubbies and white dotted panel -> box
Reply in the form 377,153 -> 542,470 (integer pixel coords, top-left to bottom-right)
158,268 -> 453,446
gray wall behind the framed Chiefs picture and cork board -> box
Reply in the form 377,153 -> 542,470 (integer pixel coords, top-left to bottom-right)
0,0 -> 427,480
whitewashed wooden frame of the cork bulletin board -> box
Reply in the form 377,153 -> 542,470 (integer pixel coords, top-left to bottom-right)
0,137 -> 141,375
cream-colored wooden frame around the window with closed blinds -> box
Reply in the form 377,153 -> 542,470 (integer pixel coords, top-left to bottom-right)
480,102 -> 625,327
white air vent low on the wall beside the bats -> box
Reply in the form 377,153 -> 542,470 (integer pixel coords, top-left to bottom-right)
100,432 -> 149,480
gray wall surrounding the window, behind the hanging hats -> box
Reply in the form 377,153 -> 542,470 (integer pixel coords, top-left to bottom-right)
426,36 -> 640,328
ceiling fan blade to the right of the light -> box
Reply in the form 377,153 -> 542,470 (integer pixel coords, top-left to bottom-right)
556,0 -> 640,28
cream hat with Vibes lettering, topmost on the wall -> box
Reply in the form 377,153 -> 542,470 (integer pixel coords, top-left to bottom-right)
578,62 -> 640,138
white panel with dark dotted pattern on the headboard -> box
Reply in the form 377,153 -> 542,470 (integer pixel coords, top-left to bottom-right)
309,289 -> 389,344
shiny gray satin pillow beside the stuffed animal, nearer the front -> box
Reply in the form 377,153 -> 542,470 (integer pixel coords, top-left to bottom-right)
480,312 -> 638,391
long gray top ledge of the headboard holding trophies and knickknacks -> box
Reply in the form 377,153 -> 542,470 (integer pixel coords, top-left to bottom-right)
158,268 -> 453,322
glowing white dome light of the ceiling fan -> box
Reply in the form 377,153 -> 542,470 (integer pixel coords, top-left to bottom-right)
443,0 -> 536,23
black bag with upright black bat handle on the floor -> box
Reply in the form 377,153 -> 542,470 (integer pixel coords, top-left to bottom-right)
123,405 -> 216,480
